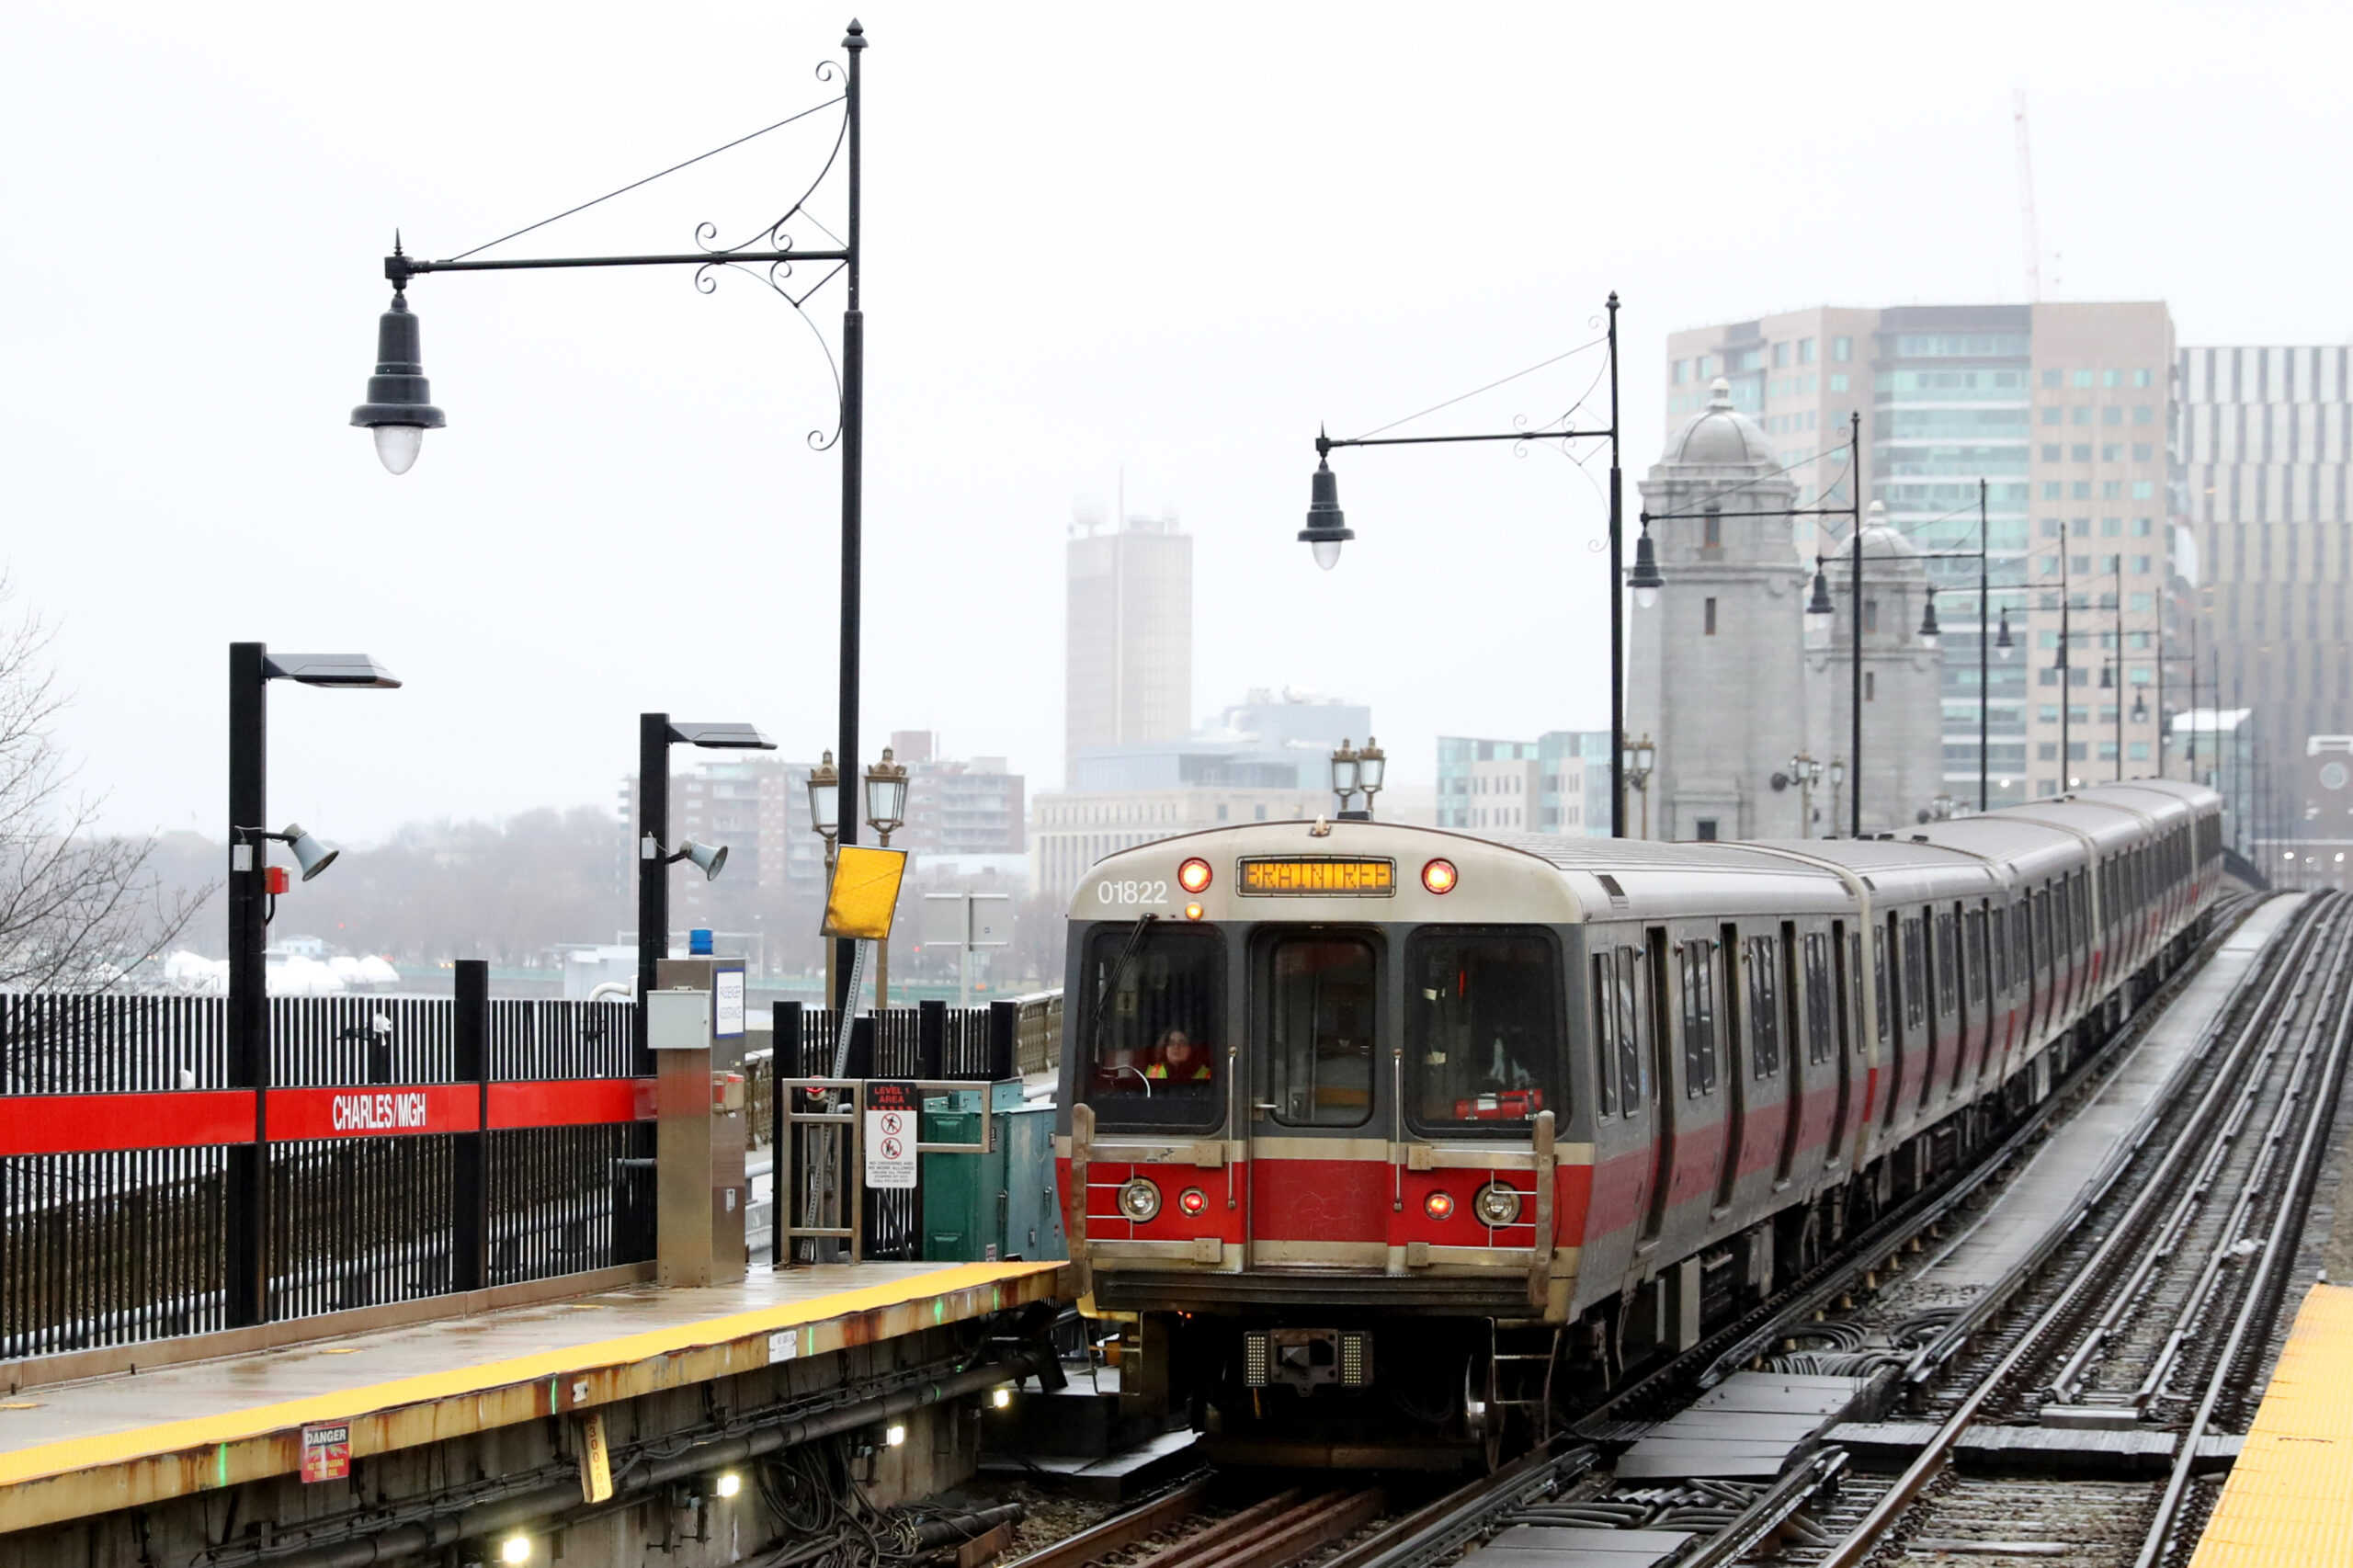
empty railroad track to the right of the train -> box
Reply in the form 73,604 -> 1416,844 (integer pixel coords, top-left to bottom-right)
1756,897 -> 2353,1568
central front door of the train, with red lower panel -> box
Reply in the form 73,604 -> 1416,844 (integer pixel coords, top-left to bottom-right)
1245,927 -> 1395,1269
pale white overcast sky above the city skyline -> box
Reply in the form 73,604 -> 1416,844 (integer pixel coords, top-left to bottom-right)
0,0 -> 2353,840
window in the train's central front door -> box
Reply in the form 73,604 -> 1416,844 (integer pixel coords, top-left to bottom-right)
1266,935 -> 1374,1128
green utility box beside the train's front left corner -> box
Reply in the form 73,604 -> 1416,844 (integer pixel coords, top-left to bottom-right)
920,1078 -> 1071,1262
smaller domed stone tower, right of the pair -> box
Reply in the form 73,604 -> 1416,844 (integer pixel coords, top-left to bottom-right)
1805,502 -> 1948,838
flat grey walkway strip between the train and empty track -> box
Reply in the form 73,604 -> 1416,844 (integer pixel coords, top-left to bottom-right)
1880,894 -> 2303,1318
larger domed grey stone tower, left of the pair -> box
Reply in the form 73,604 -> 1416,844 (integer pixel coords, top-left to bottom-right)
1626,379 -> 1807,838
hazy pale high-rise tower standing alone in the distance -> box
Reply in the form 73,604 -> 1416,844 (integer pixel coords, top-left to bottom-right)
1063,513 -> 1193,772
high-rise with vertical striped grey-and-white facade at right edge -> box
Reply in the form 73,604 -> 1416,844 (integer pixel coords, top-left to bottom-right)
2165,347 -> 2353,828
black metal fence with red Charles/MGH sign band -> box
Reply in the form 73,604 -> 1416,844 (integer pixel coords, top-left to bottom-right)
0,974 -> 654,1358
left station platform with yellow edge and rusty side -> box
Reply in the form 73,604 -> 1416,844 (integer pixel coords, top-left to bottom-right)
0,1262 -> 1066,1535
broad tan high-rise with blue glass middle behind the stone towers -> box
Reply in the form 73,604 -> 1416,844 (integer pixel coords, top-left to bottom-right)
1665,301 -> 2186,805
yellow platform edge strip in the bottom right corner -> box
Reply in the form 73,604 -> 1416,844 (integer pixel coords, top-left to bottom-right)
2190,1286 -> 2353,1568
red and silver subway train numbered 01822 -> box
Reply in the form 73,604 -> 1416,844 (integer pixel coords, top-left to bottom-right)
1056,781 -> 2222,1464
